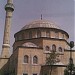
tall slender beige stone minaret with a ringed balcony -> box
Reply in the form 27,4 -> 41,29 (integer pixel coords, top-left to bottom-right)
1,0 -> 14,58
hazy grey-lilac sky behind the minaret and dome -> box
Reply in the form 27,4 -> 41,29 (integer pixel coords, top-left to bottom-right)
0,0 -> 75,51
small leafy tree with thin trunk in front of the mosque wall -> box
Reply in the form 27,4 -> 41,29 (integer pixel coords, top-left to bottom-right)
46,51 -> 60,75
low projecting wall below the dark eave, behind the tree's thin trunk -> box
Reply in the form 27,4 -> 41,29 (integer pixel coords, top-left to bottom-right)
41,66 -> 64,75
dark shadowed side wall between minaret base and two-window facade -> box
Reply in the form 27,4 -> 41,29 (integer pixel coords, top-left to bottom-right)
7,50 -> 18,75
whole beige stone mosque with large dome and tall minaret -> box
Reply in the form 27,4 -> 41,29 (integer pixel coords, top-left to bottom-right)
0,0 -> 75,75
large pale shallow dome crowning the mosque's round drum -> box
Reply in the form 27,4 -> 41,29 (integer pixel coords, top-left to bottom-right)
22,20 -> 60,30
